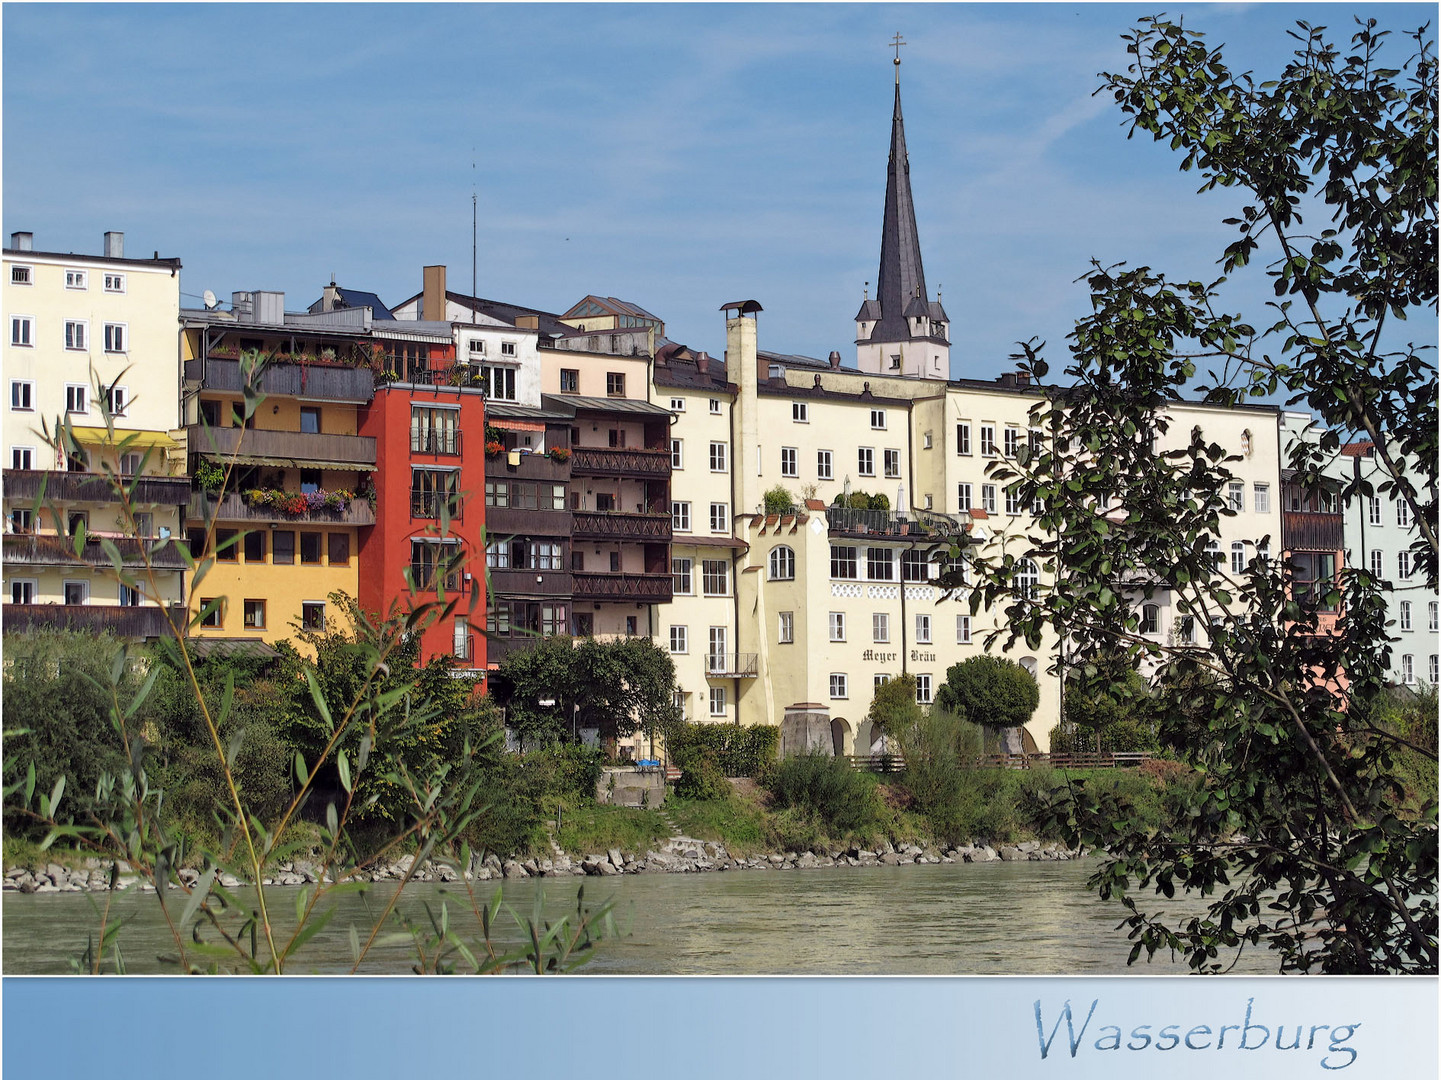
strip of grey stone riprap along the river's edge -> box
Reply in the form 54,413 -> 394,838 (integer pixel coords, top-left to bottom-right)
4,836 -> 1081,893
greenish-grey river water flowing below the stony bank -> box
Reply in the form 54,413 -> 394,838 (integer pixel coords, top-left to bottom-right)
3,861 -> 1275,975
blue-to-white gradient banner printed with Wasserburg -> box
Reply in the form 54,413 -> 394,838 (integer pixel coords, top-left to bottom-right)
3,976 -> 1438,1080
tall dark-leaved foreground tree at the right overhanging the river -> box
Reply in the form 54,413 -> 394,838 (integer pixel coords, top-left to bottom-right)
973,19 -> 1437,973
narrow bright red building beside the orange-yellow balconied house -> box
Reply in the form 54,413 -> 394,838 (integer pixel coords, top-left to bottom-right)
359,322 -> 486,672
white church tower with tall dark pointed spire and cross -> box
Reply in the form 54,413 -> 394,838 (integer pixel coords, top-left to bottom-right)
856,42 -> 951,379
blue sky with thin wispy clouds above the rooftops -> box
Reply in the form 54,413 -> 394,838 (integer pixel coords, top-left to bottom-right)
3,3 -> 1435,378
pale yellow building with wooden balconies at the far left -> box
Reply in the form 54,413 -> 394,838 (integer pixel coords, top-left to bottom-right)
3,232 -> 189,637
